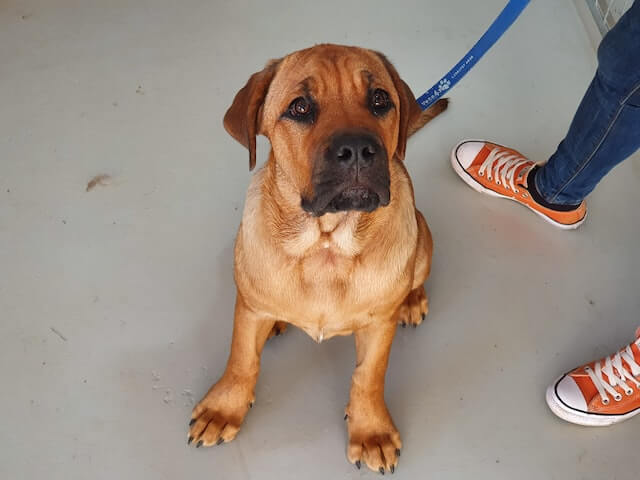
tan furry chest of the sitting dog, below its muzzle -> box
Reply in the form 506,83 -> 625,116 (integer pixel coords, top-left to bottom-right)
236,183 -> 415,342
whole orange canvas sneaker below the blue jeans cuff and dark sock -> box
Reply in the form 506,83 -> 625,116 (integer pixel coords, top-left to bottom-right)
451,140 -> 587,230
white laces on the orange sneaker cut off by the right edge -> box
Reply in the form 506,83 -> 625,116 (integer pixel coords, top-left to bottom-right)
584,338 -> 640,405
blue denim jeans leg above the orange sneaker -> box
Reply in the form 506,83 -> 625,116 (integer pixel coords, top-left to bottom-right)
535,0 -> 640,205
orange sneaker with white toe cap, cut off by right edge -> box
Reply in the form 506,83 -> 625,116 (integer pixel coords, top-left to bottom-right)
547,328 -> 640,426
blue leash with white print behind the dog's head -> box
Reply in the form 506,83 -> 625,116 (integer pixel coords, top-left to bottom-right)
417,0 -> 529,110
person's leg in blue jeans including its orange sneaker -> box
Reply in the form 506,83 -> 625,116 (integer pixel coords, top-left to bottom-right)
451,0 -> 640,229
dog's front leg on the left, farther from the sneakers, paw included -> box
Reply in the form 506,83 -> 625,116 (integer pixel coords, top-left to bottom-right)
188,295 -> 275,447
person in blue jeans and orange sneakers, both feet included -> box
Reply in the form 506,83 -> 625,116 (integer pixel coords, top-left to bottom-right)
451,4 -> 640,426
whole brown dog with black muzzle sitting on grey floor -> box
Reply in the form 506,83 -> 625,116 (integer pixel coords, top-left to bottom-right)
189,45 -> 447,473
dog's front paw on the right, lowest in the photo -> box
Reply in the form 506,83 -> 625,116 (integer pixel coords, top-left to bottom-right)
347,406 -> 402,475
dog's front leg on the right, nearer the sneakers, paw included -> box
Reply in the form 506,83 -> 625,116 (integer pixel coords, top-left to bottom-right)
346,319 -> 402,473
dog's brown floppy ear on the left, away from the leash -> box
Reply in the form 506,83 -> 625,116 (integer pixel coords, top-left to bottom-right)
224,60 -> 280,170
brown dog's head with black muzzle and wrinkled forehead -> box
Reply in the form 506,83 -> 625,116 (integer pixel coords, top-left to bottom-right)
224,45 -> 419,216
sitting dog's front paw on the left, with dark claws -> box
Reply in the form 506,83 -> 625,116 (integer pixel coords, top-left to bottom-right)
187,380 -> 253,448
